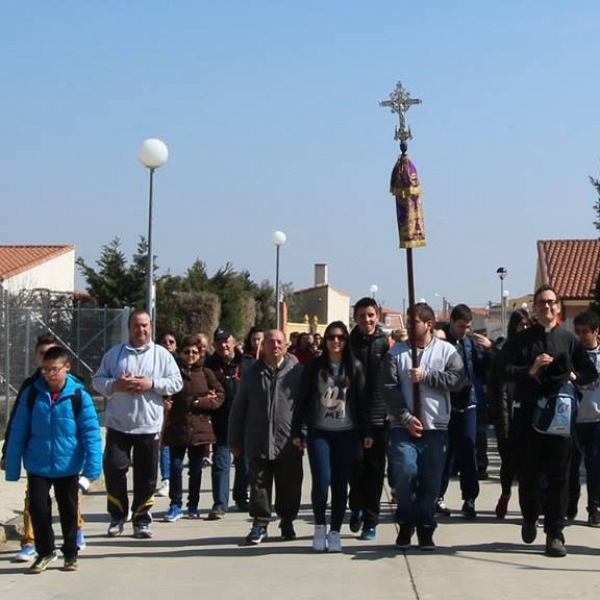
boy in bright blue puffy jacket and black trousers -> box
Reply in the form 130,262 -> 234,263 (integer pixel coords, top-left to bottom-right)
5,346 -> 102,573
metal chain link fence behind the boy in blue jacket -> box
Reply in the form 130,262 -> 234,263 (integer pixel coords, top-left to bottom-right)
0,290 -> 131,438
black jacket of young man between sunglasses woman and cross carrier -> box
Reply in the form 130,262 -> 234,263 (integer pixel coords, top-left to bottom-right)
350,327 -> 389,427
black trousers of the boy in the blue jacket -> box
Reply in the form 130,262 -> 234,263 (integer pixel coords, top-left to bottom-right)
27,473 -> 79,558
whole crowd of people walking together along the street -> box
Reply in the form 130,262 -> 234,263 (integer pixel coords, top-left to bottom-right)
2,286 -> 600,573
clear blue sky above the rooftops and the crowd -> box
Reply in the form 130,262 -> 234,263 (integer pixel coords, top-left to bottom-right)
0,0 -> 600,309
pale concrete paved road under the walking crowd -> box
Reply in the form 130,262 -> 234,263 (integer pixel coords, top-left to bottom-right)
0,438 -> 600,600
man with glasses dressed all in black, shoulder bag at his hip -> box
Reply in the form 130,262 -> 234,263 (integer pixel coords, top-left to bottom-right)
503,285 -> 598,557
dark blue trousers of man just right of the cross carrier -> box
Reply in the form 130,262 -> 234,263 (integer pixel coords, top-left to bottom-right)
439,405 -> 479,500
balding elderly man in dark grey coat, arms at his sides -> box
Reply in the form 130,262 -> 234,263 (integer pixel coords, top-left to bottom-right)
228,329 -> 303,544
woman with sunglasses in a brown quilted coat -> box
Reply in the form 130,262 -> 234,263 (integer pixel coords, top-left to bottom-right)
163,336 -> 225,523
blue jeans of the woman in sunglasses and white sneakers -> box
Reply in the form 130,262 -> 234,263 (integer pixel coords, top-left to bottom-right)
306,429 -> 358,531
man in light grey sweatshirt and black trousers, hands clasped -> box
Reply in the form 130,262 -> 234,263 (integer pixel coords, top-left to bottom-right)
92,310 -> 183,538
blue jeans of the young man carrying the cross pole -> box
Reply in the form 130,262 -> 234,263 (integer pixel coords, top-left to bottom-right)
389,427 -> 448,527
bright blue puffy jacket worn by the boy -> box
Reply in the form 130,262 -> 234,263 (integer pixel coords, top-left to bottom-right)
6,375 -> 102,481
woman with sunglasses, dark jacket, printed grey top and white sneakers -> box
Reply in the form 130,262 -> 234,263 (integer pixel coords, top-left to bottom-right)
293,321 -> 372,552
